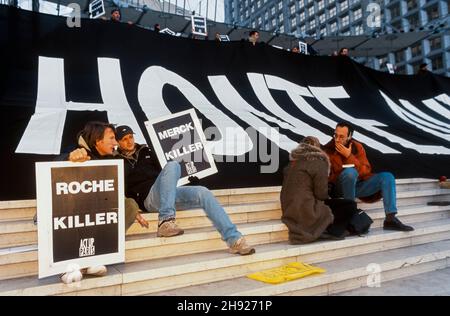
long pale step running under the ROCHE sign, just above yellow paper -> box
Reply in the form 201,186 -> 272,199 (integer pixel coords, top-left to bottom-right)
0,220 -> 450,295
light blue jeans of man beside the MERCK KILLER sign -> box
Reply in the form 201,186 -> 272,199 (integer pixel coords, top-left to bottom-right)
144,161 -> 242,246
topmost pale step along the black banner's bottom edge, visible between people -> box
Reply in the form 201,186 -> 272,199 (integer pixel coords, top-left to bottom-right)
0,178 -> 438,222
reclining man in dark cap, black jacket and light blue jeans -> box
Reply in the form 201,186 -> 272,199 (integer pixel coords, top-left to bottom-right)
116,125 -> 255,255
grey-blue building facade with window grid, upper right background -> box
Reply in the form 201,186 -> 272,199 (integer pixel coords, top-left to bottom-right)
225,0 -> 450,76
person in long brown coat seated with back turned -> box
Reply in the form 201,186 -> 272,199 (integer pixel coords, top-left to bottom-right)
281,136 -> 333,244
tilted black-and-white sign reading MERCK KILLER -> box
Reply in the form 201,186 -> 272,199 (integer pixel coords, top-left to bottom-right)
145,109 -> 217,185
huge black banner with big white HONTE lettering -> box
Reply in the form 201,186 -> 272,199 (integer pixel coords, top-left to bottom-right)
0,6 -> 450,200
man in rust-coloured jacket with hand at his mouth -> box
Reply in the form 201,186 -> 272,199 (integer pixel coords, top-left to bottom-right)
324,122 -> 414,231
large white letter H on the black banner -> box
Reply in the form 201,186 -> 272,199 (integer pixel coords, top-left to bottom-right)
16,56 -> 145,154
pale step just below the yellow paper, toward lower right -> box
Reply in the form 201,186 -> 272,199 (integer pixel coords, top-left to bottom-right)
154,240 -> 450,296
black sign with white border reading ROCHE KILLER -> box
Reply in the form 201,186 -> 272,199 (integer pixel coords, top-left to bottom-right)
36,160 -> 125,278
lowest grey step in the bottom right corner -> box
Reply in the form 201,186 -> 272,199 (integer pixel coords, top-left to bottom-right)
336,268 -> 450,296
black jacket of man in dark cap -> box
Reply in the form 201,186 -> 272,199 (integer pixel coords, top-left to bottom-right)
118,144 -> 161,211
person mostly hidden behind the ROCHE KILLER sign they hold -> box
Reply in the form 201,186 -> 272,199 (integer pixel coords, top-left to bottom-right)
59,122 -> 148,283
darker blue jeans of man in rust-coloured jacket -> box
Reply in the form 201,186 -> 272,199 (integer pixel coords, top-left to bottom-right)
336,168 -> 397,214
